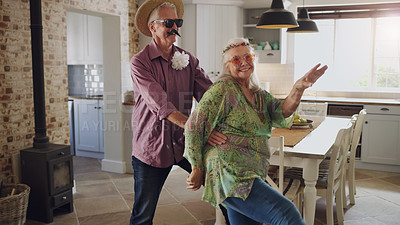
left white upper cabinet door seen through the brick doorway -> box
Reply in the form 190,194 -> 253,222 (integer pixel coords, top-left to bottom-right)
67,12 -> 85,64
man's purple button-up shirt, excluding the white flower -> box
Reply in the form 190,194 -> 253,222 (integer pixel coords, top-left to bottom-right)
131,39 -> 212,168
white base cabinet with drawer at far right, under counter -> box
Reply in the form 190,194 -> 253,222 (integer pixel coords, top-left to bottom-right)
361,105 -> 400,165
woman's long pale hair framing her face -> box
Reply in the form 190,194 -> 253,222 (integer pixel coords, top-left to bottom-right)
218,38 -> 261,92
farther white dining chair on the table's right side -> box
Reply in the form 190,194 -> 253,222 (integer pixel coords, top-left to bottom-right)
343,109 -> 367,208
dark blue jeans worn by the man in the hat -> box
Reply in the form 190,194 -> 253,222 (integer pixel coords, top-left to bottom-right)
130,156 -> 192,225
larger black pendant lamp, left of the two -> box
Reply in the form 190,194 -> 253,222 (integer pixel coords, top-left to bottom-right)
256,0 -> 298,29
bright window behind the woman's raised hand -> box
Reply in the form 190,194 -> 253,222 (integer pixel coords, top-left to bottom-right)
294,12 -> 400,92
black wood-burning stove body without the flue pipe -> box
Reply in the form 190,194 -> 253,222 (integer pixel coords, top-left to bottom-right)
21,144 -> 73,223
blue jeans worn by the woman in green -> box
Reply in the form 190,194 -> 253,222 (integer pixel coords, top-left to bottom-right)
222,179 -> 306,225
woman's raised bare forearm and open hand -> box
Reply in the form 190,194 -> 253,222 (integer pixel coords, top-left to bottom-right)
282,64 -> 328,118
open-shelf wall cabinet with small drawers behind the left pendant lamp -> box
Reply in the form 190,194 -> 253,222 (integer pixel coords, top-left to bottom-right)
243,8 -> 286,64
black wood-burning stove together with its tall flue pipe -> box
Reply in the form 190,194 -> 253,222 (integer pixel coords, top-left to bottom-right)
20,0 -> 74,223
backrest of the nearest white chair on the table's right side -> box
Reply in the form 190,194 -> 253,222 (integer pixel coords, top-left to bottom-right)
327,123 -> 353,190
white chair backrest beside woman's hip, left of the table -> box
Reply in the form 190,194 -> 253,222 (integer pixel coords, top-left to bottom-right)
267,136 -> 285,194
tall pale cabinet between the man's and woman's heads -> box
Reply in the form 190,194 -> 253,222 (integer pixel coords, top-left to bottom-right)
181,1 -> 243,81
